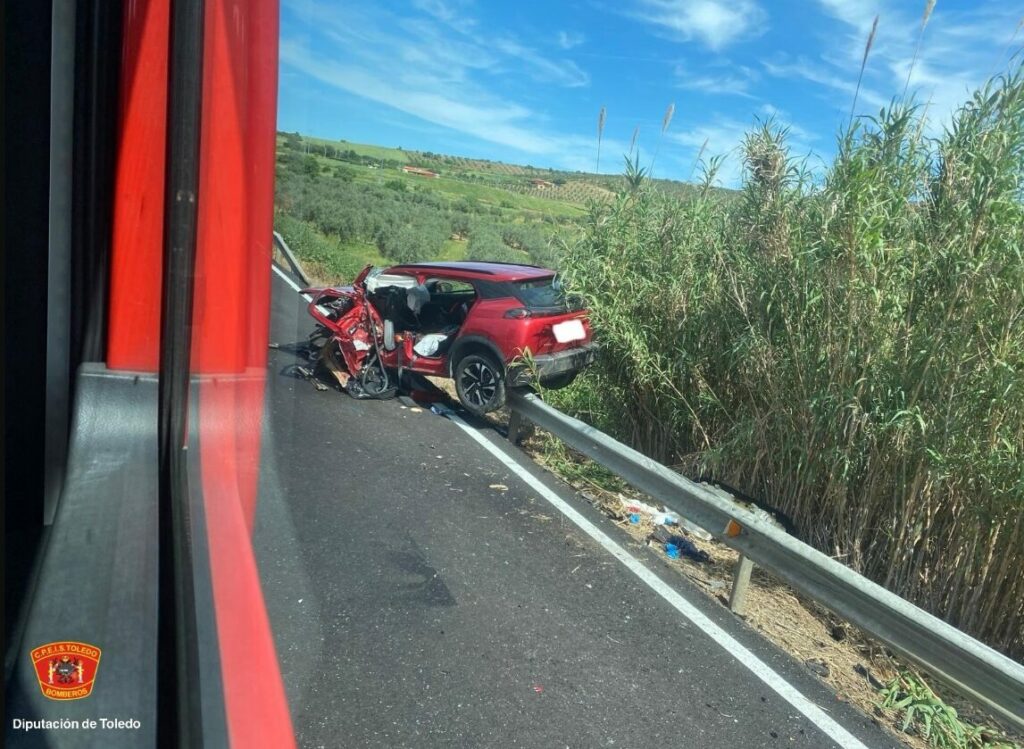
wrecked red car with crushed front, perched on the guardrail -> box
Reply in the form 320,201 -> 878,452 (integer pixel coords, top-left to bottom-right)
304,262 -> 594,414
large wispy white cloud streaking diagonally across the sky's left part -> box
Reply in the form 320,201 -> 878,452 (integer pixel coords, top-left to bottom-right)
281,0 -> 594,163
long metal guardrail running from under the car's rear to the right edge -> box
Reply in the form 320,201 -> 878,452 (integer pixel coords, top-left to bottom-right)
509,391 -> 1024,729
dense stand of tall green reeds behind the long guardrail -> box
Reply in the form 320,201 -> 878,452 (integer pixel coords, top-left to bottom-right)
553,70 -> 1024,658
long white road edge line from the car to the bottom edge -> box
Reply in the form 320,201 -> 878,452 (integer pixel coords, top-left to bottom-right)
447,414 -> 867,749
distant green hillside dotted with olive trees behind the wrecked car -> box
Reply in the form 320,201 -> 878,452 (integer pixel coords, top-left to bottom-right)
275,132 -> 720,281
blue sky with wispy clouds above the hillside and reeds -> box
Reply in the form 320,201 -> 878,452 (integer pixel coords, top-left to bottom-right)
279,0 -> 1024,185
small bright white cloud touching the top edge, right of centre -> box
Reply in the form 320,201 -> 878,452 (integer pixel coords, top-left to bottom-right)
626,0 -> 768,49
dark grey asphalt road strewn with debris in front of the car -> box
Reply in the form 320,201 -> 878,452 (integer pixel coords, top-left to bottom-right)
255,275 -> 895,749
